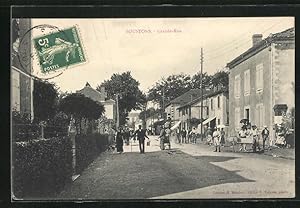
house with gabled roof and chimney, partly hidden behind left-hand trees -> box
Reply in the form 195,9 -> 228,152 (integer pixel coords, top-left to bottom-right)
76,82 -> 117,132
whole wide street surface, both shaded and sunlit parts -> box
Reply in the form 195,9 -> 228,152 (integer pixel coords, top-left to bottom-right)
56,137 -> 295,200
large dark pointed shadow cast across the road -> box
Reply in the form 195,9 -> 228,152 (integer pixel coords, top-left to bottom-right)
57,149 -> 251,200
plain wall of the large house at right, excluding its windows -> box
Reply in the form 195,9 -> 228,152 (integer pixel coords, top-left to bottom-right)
228,47 -> 272,136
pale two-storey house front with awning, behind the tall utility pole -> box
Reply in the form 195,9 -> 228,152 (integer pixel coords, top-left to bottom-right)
178,88 -> 229,133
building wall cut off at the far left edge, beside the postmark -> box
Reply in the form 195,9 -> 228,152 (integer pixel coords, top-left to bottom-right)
11,19 -> 34,119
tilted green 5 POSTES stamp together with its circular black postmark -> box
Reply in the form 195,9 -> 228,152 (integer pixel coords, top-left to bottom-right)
17,24 -> 87,80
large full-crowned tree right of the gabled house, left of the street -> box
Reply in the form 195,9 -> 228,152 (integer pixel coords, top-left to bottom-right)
97,71 -> 146,125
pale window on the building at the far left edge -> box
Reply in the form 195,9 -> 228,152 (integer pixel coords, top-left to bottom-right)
11,70 -> 20,111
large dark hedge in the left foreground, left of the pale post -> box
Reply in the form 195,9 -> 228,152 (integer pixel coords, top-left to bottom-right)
12,137 -> 72,199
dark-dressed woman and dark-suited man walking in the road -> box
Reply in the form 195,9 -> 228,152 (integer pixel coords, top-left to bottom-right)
116,125 -> 149,153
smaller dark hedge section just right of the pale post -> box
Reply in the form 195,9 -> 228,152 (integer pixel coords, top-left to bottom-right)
75,133 -> 111,174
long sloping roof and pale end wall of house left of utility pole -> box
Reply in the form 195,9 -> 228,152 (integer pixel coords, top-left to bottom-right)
165,89 -> 201,125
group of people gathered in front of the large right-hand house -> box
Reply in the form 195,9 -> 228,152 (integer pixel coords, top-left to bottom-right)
238,124 -> 270,152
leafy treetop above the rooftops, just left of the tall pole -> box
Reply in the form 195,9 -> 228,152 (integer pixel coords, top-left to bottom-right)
148,74 -> 191,106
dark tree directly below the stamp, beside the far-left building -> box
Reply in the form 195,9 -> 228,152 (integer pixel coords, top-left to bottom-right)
33,80 -> 58,122
